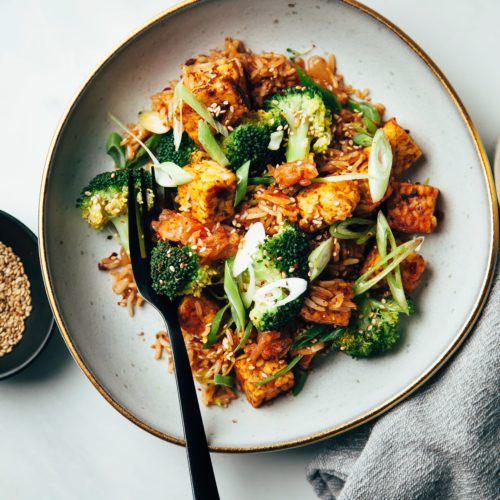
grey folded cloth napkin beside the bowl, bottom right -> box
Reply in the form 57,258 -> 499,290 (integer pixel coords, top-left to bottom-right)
307,260 -> 500,500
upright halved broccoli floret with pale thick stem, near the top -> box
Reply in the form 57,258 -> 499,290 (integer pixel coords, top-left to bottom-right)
264,87 -> 332,162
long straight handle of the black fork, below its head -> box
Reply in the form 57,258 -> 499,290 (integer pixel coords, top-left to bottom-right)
161,310 -> 219,500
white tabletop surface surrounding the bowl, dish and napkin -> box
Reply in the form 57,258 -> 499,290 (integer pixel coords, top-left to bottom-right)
0,0 -> 500,500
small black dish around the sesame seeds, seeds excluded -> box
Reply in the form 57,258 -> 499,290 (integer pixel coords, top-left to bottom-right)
0,210 -> 54,380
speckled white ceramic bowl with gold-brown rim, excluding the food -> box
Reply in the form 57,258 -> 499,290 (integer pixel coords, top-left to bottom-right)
39,0 -> 497,451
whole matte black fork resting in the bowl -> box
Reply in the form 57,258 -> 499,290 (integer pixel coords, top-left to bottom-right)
128,168 -> 219,500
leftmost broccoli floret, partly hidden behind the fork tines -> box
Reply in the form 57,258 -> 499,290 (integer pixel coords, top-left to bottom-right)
76,169 -> 153,252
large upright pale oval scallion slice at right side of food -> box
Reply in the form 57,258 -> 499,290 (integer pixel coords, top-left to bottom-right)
368,128 -> 392,203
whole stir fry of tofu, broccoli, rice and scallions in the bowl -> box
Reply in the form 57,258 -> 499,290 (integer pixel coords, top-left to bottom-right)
77,38 -> 439,408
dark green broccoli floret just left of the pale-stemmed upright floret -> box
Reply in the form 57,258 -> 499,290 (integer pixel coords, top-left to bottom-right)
222,110 -> 286,173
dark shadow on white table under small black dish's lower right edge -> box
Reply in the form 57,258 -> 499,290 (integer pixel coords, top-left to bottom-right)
3,326 -> 72,384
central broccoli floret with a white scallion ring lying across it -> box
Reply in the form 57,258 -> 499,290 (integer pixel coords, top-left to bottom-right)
249,224 -> 309,331
